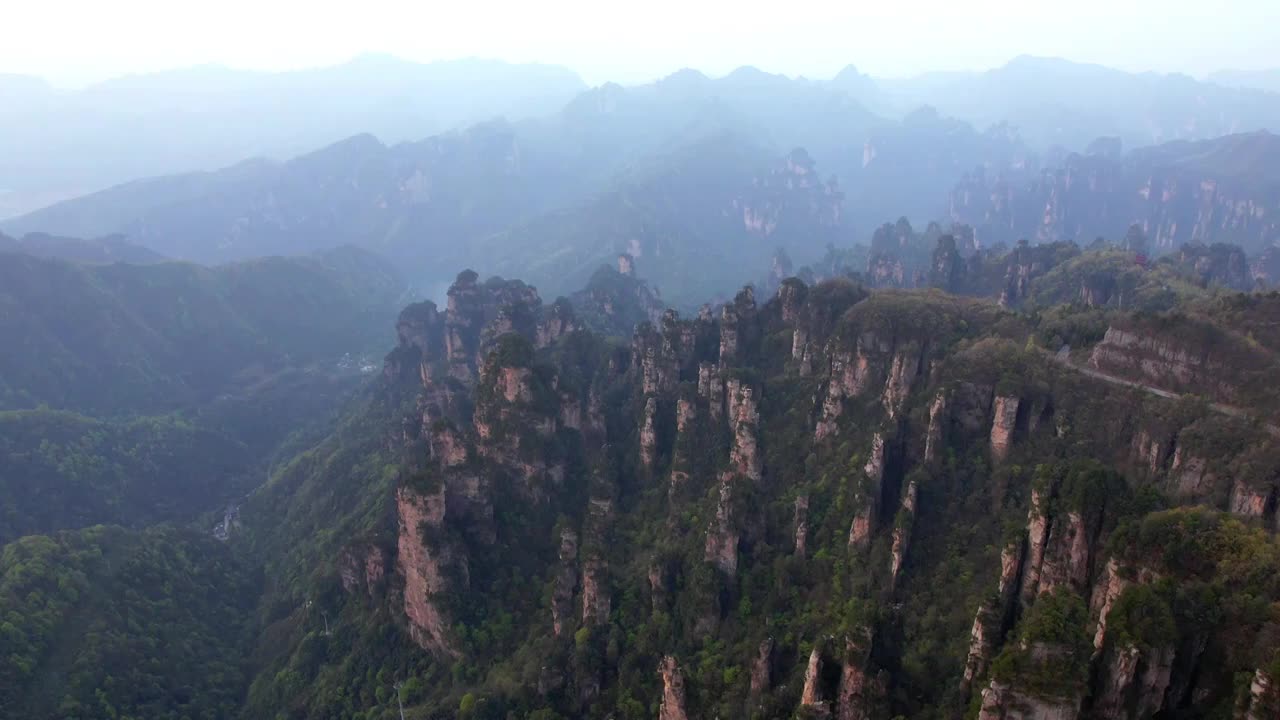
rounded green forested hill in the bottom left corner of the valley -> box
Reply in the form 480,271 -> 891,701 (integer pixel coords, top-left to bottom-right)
0,527 -> 259,720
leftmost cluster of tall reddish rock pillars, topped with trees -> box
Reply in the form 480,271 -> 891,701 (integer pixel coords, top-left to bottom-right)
385,272 -> 608,655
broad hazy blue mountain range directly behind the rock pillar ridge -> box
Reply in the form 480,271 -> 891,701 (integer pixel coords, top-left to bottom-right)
4,68 -> 1039,298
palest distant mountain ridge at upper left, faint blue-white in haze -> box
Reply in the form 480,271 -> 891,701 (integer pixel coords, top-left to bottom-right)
0,55 -> 585,217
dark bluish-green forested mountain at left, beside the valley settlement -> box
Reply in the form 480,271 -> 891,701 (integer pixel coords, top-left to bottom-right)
0,249 -> 404,414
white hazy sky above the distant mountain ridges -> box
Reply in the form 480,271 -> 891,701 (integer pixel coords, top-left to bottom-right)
10,0 -> 1280,85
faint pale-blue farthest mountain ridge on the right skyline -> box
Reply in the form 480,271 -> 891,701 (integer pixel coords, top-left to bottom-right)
878,55 -> 1280,150
